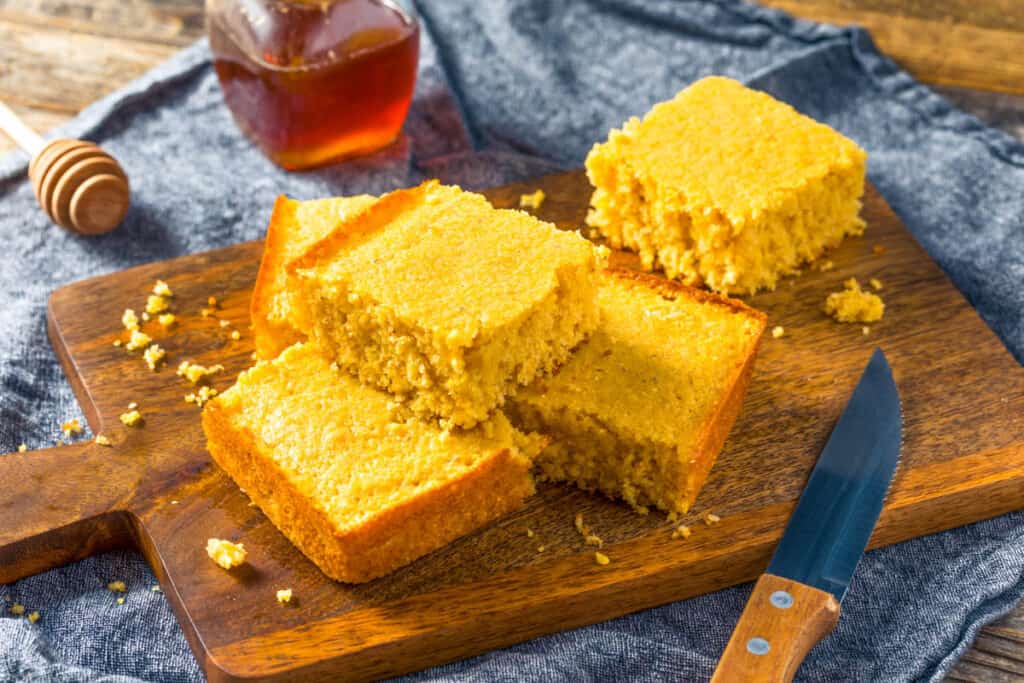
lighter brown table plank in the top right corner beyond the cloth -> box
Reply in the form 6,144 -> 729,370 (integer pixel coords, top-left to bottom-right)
762,0 -> 1024,93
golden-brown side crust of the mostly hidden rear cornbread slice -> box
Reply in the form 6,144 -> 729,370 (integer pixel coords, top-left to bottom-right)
249,195 -> 301,359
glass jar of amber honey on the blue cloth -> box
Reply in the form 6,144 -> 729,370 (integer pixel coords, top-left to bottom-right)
207,0 -> 420,170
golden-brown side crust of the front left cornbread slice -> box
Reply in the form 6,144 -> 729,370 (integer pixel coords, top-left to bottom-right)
203,399 -> 534,583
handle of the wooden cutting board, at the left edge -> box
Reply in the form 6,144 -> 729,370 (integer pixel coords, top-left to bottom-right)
0,441 -> 139,584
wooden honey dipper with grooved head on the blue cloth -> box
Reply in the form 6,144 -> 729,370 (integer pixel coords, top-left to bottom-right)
0,96 -> 130,234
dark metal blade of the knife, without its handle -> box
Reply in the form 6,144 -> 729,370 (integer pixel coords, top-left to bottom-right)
768,348 -> 903,601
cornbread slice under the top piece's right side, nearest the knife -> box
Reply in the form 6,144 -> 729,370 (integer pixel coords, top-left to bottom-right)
506,269 -> 766,513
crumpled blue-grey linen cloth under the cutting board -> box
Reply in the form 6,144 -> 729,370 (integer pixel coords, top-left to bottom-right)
0,0 -> 1024,682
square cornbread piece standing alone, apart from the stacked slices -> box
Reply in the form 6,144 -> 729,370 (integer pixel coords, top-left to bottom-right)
587,77 -> 866,293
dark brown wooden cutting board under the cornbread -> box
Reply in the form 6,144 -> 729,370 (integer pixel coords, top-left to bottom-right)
0,172 -> 1024,681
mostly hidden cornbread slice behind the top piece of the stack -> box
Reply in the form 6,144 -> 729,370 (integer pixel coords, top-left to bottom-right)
249,195 -> 377,360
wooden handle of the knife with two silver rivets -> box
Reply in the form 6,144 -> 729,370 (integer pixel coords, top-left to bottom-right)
711,573 -> 839,683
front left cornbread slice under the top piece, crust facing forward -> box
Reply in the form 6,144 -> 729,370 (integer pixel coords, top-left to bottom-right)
195,343 -> 543,583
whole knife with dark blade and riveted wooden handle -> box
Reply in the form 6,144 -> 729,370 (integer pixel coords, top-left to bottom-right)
711,348 -> 903,683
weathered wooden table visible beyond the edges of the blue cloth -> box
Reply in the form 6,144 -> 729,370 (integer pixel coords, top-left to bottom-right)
0,0 -> 1024,683
